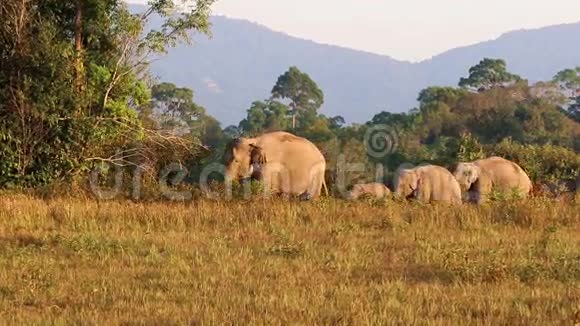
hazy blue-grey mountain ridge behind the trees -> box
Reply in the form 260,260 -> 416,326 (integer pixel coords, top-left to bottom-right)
137,6 -> 580,125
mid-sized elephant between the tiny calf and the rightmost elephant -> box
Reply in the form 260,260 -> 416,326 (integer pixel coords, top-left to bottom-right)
393,165 -> 462,204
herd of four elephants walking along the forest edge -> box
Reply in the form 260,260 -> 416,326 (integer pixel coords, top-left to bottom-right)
224,132 -> 572,204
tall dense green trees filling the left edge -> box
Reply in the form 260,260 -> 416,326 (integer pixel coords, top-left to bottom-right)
0,0 -> 213,186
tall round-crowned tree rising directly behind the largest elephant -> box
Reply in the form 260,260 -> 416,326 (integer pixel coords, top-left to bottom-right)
272,67 -> 324,129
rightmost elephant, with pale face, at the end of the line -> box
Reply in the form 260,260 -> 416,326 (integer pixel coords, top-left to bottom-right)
454,156 -> 532,204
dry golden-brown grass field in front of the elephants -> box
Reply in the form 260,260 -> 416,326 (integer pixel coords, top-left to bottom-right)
0,195 -> 580,325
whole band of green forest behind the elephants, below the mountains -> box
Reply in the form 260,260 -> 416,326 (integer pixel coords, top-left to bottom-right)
0,0 -> 580,188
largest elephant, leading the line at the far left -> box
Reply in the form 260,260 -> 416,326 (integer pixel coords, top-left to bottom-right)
224,131 -> 326,199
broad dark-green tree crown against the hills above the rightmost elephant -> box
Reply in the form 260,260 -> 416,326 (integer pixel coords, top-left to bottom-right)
459,58 -> 522,92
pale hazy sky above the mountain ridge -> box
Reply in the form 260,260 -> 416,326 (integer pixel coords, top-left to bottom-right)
129,0 -> 580,61
